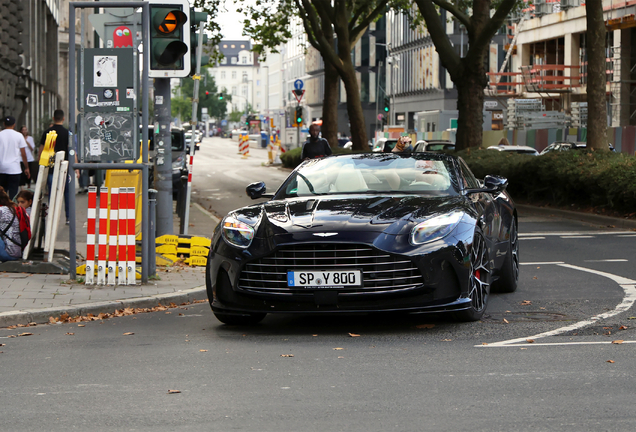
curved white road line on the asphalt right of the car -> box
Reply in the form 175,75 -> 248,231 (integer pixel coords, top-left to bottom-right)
475,264 -> 636,348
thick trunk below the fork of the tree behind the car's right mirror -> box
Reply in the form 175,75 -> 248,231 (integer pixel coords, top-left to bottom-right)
453,58 -> 488,150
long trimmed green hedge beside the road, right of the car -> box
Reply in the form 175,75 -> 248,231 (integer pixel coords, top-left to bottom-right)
458,149 -> 636,212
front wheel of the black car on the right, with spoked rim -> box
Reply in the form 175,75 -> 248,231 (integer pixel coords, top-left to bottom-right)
454,227 -> 492,321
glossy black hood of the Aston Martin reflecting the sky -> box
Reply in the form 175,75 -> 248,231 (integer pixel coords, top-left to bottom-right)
232,195 -> 466,240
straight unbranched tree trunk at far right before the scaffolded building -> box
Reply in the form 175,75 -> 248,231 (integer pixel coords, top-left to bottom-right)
585,0 -> 608,150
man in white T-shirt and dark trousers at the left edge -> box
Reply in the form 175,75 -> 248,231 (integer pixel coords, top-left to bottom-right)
0,116 -> 31,199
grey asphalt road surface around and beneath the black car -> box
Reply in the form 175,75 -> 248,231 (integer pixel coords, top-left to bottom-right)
0,140 -> 636,431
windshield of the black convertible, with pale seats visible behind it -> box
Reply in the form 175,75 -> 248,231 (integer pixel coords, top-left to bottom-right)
275,153 -> 459,199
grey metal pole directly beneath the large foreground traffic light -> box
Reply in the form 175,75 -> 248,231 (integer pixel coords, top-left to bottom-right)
154,78 -> 173,236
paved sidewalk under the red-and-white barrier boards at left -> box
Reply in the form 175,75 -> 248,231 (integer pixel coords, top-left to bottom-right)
0,191 -> 219,328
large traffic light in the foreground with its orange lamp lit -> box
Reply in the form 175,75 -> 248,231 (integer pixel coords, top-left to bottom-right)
148,0 -> 191,78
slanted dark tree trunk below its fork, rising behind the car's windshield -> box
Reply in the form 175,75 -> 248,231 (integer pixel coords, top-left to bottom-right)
340,57 -> 369,151
